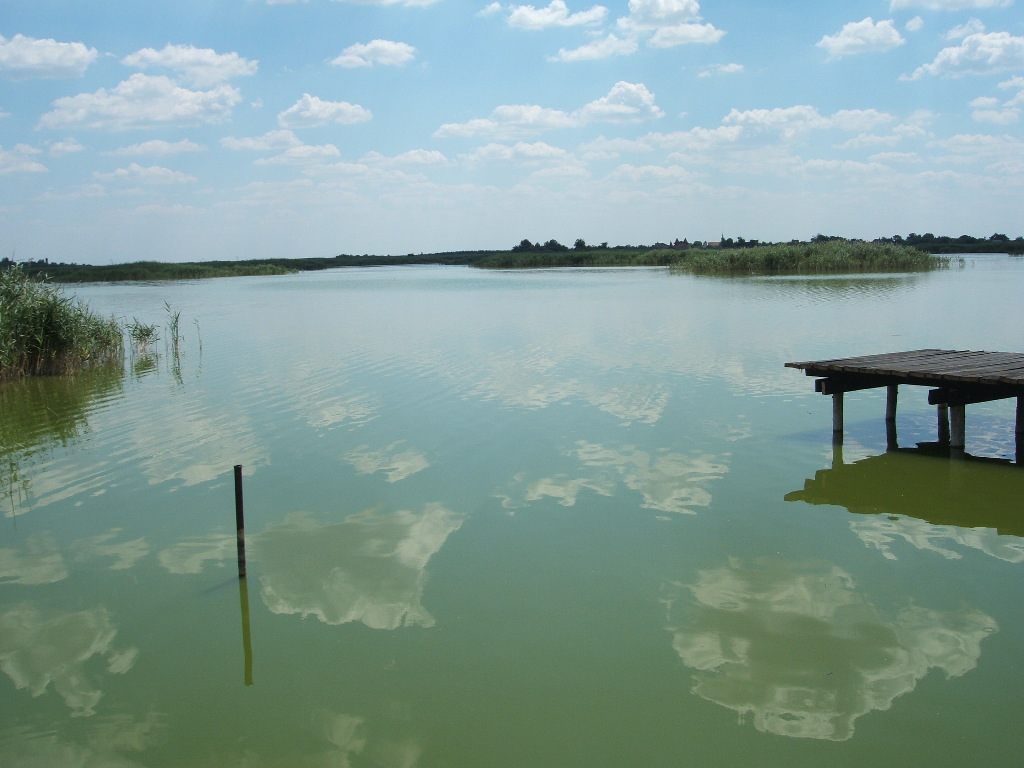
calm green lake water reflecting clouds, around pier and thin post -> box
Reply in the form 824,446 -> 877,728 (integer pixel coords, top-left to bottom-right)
0,255 -> 1024,768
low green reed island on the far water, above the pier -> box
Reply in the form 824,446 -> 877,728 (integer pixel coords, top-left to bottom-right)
678,240 -> 948,274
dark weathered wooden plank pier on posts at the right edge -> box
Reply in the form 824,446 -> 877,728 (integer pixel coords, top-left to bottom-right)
785,349 -> 1024,464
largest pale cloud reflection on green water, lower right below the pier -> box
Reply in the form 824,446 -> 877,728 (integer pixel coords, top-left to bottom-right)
665,559 -> 997,741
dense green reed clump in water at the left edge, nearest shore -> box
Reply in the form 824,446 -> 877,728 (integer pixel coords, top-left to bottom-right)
0,264 -> 124,380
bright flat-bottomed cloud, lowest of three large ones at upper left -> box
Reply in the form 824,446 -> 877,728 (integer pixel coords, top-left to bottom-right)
39,74 -> 242,130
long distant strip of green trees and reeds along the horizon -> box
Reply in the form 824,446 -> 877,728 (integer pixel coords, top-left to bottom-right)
6,232 -> 1024,283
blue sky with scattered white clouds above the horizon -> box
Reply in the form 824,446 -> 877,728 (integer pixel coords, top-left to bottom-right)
0,0 -> 1024,264
